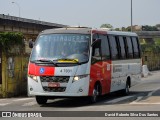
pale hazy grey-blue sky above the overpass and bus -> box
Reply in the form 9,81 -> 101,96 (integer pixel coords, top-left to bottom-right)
0,0 -> 160,28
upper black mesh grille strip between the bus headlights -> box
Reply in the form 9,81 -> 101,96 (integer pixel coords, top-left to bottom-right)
40,76 -> 69,83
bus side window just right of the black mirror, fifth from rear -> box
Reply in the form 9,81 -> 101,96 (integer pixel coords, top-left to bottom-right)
99,35 -> 110,60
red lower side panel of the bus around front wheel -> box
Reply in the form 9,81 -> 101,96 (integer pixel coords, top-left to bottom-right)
88,61 -> 112,96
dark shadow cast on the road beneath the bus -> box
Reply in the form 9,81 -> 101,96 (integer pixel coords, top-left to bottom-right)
41,91 -> 151,108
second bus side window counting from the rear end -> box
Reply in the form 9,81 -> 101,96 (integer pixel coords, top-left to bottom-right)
125,37 -> 133,58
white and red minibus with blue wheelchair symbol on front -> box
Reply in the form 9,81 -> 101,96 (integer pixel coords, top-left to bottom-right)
28,27 -> 142,104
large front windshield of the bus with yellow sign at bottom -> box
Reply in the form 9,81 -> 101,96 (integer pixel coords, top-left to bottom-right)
30,34 -> 90,63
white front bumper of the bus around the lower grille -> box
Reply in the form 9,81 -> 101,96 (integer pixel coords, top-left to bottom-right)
28,75 -> 89,97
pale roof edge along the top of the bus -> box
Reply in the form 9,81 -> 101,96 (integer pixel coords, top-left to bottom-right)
41,27 -> 137,36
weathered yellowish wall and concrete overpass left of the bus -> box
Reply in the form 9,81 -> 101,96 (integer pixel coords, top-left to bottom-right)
0,14 -> 67,97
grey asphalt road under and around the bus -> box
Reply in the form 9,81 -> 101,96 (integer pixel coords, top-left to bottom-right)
0,71 -> 160,120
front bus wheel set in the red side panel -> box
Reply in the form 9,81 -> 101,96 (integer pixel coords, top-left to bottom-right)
90,84 -> 99,103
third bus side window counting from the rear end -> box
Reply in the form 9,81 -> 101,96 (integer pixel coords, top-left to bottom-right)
119,36 -> 126,59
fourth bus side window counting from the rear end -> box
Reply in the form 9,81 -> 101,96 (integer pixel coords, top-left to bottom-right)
108,35 -> 118,60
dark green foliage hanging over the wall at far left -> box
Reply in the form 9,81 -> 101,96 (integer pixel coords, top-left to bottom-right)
0,32 -> 24,53
